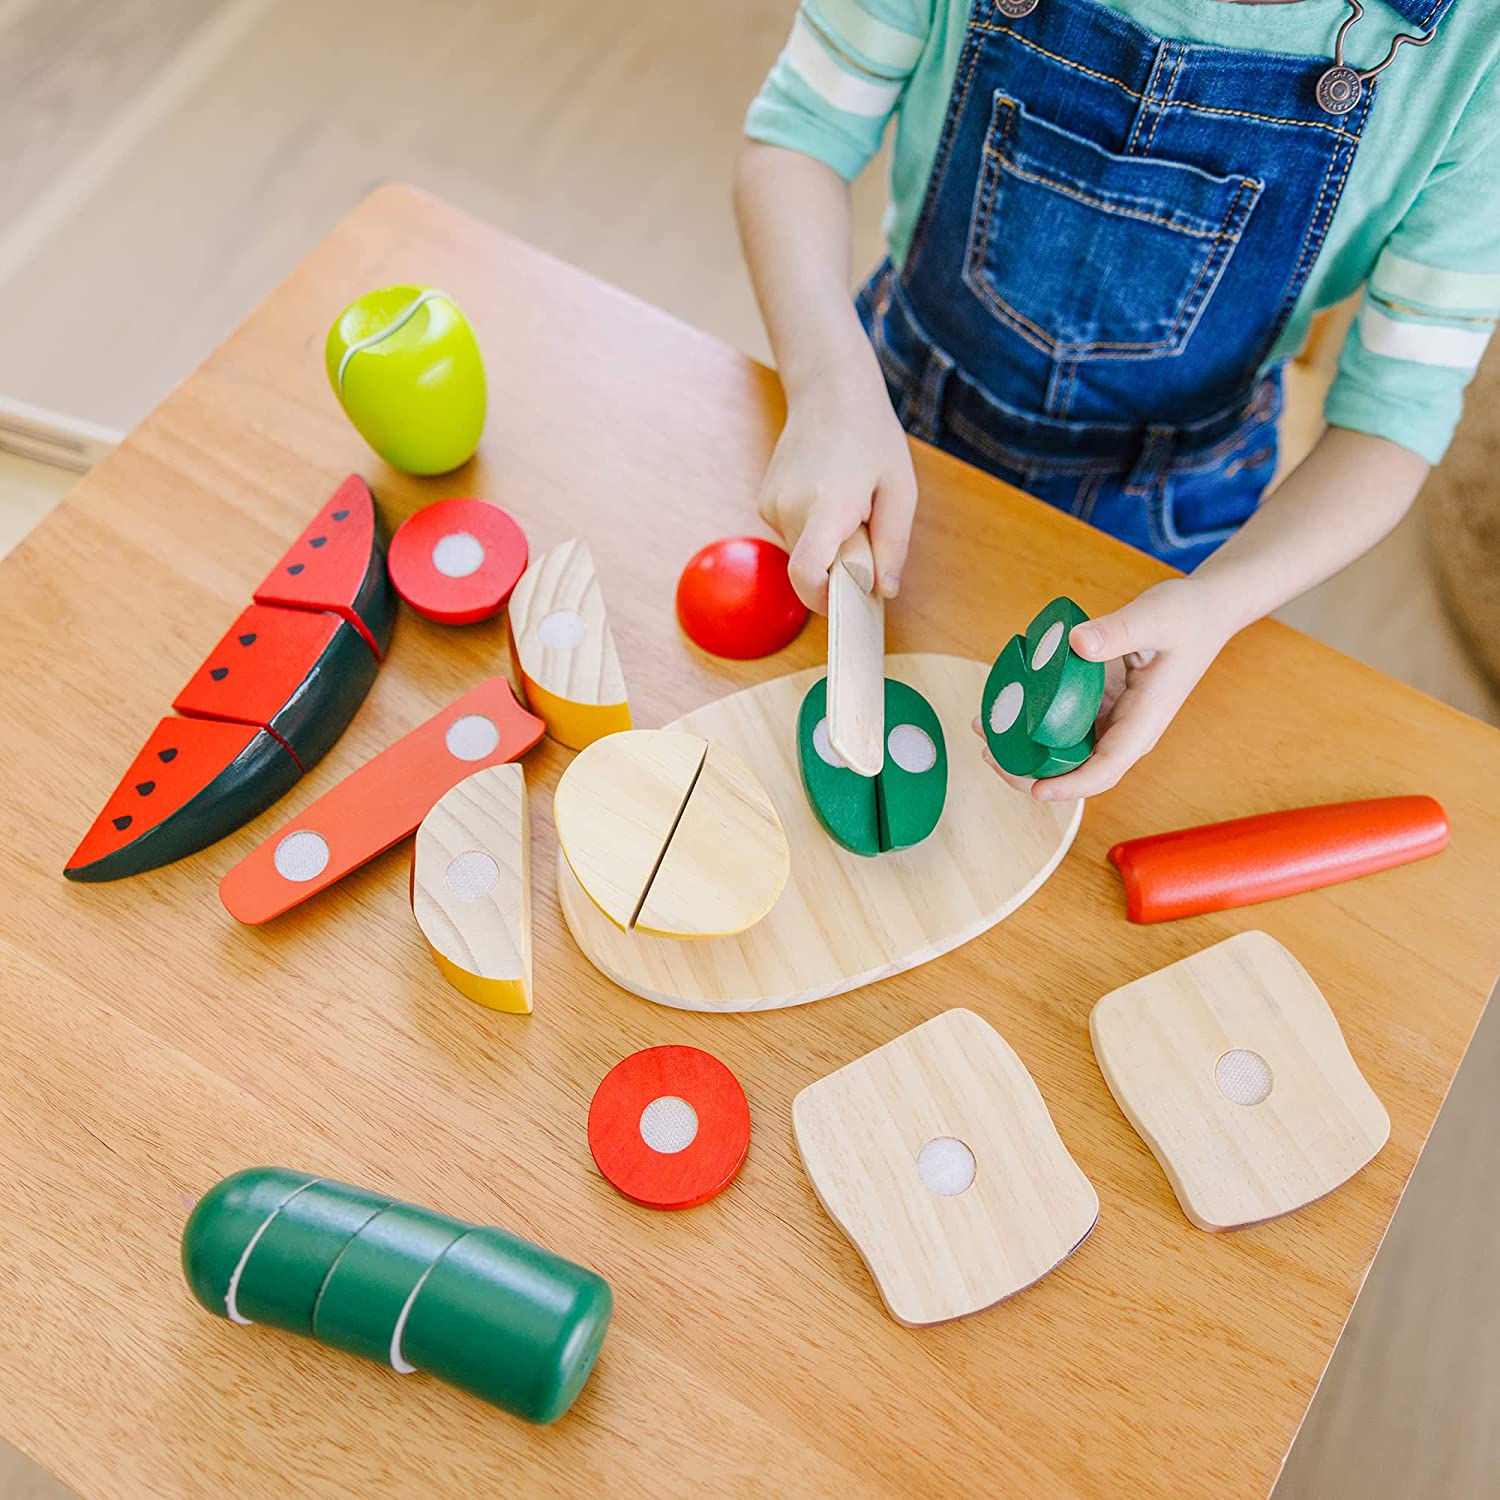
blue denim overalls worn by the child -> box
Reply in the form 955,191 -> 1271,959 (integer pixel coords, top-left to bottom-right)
858,0 -> 1452,570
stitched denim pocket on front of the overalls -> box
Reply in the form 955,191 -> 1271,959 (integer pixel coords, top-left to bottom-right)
963,92 -> 1265,360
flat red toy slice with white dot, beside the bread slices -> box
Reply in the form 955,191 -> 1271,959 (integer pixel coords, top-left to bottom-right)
588,1047 -> 750,1209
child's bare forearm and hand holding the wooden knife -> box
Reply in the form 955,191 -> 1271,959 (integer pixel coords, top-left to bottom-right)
735,141 -> 917,611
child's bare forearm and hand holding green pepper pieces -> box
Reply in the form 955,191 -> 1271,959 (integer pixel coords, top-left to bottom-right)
984,428 -> 1430,801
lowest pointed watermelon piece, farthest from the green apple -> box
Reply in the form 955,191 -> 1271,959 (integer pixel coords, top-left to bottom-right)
63,719 -> 302,881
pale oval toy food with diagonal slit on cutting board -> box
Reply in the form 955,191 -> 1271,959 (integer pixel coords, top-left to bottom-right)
552,729 -> 791,938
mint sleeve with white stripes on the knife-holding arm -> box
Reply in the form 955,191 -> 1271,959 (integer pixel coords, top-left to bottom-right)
746,0 -> 933,179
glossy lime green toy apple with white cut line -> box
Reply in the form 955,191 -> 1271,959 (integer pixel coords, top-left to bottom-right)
324,287 -> 485,474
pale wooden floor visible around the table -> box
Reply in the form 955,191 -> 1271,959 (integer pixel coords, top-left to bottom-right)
0,0 -> 1500,1500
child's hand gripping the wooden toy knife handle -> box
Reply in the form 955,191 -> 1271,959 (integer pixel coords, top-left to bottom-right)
761,378 -> 917,614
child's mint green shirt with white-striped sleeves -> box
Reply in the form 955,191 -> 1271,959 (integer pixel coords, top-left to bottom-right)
746,0 -> 1500,464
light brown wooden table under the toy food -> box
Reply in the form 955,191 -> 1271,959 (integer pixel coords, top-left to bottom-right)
0,189 -> 1500,1500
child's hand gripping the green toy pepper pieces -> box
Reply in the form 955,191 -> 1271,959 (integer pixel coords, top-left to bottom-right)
974,578 -> 1229,803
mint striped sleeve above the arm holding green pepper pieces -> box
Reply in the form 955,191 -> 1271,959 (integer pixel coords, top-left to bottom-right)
1326,77 -> 1500,464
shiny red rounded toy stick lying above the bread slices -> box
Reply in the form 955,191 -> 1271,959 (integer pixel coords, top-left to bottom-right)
1110,797 -> 1448,923
